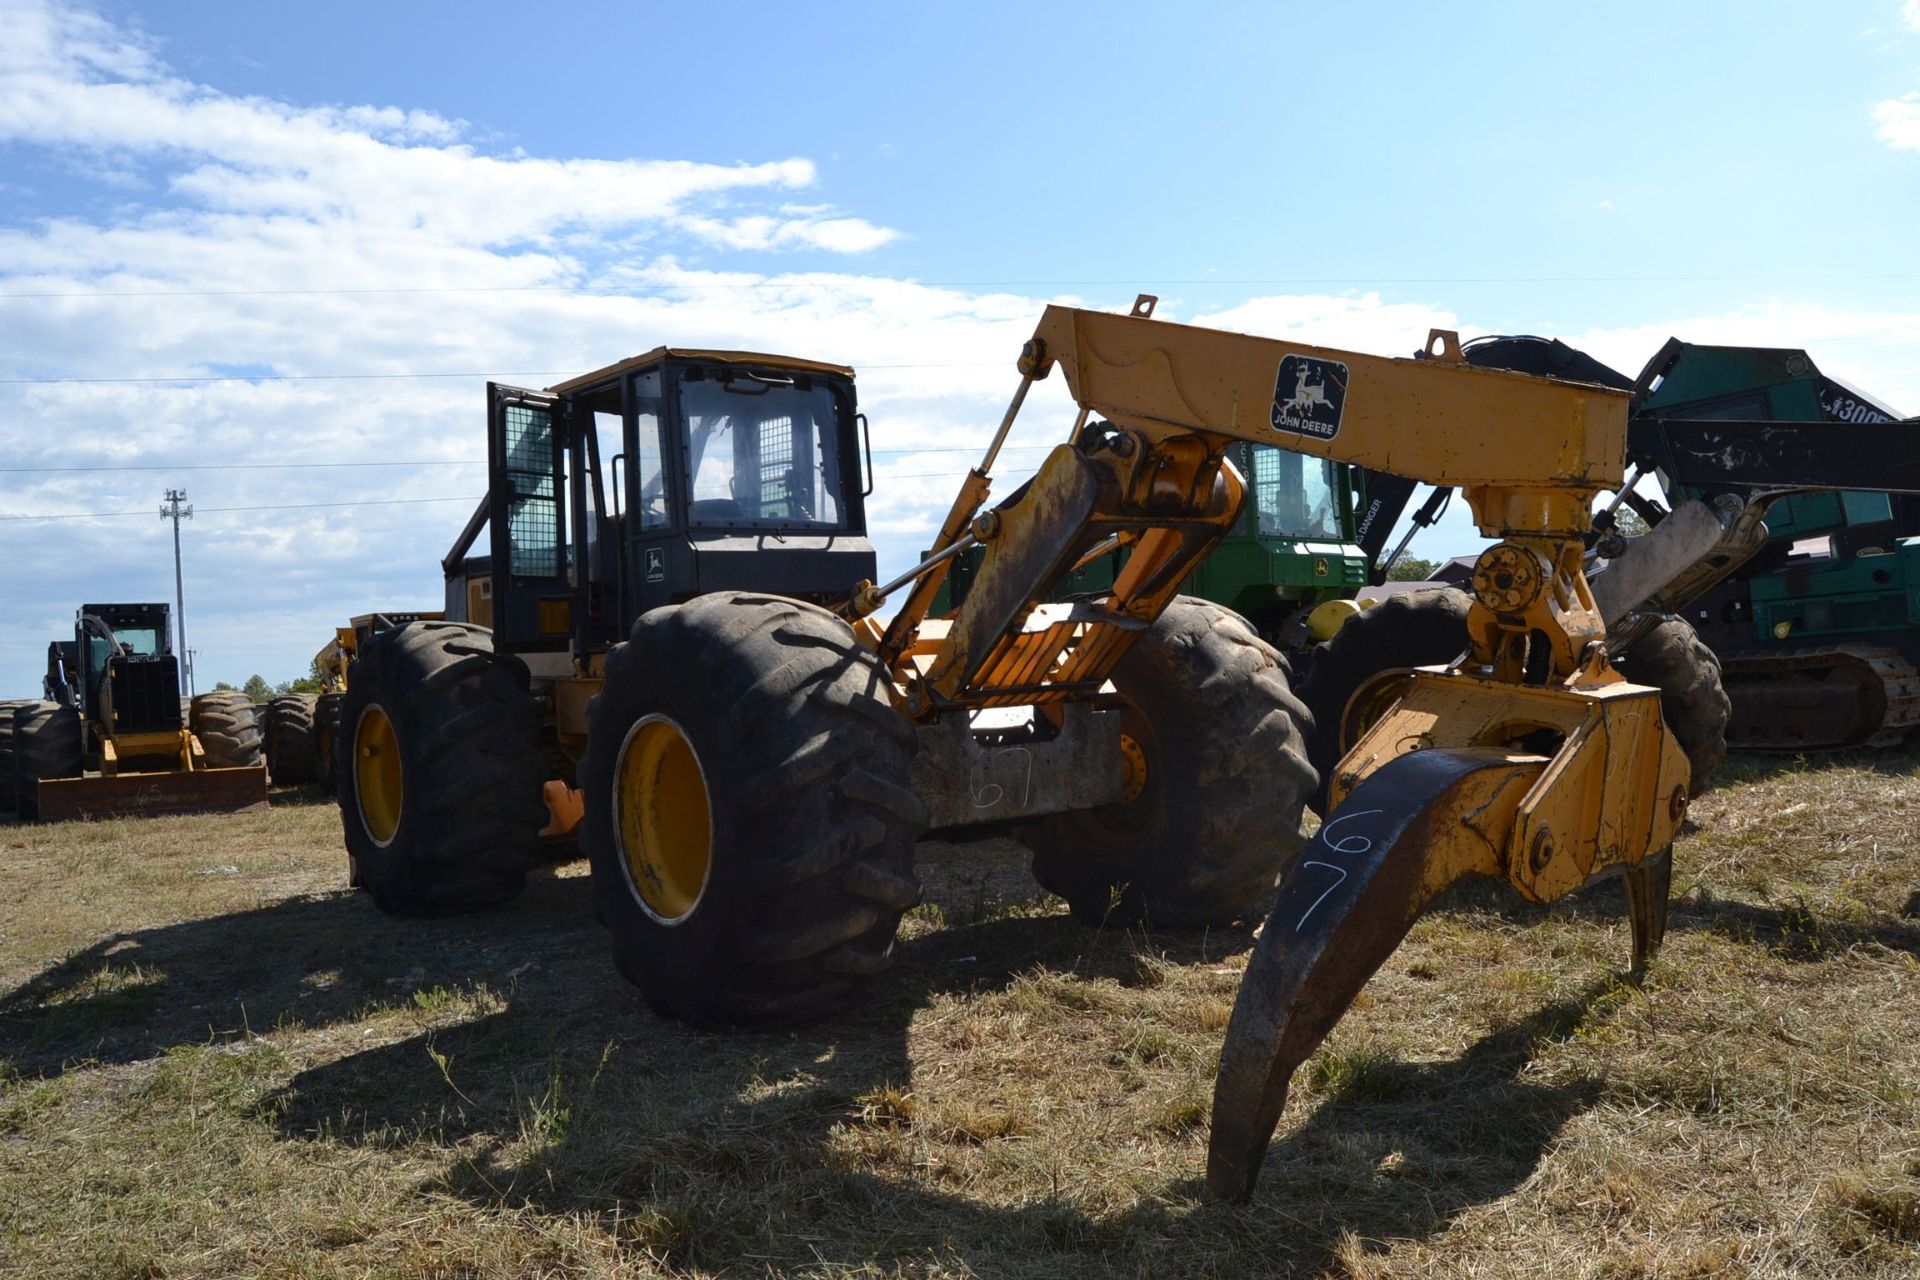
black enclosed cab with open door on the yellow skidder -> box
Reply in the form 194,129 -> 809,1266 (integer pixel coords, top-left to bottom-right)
444,347 -> 874,654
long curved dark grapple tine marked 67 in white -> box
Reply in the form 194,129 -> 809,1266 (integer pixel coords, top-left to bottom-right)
1206,750 -> 1538,1199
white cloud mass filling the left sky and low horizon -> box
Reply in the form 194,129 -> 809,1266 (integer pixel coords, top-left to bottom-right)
0,0 -> 1920,697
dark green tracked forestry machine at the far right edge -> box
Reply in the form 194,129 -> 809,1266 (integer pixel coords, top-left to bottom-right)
1465,338 -> 1920,750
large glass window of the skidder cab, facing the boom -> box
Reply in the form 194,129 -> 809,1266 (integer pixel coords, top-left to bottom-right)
680,368 -> 847,530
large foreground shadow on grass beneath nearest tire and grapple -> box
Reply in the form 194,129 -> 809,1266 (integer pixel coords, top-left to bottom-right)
236,855 -> 1611,1276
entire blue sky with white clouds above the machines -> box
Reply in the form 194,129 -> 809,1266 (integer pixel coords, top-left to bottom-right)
0,0 -> 1920,693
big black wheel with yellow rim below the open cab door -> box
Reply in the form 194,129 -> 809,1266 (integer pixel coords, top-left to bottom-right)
334,622 -> 547,915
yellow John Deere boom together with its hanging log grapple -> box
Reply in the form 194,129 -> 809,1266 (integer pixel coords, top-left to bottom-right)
849,297 -> 1688,1197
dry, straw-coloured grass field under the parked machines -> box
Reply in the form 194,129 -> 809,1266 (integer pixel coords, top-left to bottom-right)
0,752 -> 1920,1278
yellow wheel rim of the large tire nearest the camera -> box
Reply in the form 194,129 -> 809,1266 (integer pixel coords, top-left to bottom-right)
612,716 -> 712,925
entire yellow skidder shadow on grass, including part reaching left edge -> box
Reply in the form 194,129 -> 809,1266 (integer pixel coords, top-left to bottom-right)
0,836 -> 1850,1276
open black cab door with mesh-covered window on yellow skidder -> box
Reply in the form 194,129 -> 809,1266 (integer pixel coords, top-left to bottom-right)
486,382 -> 572,652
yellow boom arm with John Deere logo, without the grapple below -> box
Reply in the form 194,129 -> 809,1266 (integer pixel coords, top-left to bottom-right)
871,297 -> 1628,720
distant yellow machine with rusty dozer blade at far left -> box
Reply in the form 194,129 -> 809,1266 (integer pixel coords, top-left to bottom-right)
0,604 -> 267,821
